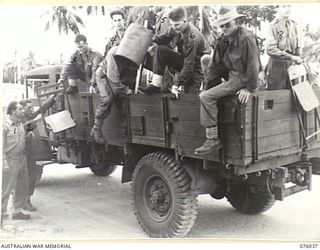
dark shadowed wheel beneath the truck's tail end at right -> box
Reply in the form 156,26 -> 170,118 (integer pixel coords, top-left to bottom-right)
227,183 -> 275,214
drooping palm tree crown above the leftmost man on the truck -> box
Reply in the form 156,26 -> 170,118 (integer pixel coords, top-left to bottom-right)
41,6 -> 85,35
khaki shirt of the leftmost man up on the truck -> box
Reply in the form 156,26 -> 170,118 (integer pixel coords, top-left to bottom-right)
61,48 -> 103,83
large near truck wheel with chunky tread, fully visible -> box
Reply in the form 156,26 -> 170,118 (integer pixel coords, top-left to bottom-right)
132,152 -> 198,238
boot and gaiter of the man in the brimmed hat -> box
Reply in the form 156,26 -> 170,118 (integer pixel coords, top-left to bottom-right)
194,126 -> 221,155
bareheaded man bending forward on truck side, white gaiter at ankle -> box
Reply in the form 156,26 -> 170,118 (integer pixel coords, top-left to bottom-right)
139,7 -> 205,97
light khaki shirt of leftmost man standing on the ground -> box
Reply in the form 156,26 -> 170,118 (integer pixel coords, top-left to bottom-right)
2,119 -> 26,161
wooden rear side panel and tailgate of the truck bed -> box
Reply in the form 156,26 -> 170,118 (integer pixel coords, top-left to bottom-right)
124,89 -> 320,167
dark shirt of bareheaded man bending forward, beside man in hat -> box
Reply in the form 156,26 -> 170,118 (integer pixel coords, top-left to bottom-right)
154,23 -> 205,86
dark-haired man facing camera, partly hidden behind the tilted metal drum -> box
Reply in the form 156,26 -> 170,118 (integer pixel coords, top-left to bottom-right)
104,10 -> 126,57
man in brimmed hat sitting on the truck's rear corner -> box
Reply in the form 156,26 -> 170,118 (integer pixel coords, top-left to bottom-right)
195,8 -> 261,154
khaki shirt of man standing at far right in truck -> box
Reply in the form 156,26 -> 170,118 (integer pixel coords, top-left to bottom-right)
266,19 -> 301,60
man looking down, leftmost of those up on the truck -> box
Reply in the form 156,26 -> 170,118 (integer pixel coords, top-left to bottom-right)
58,34 -> 103,94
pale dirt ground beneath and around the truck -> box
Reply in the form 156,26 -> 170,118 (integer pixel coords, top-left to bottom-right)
0,164 -> 320,241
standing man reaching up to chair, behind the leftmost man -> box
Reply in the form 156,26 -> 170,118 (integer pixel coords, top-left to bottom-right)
19,90 -> 63,212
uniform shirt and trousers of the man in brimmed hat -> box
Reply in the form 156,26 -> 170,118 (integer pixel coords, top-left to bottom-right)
200,27 -> 261,128
